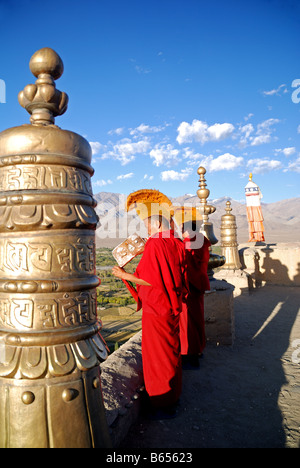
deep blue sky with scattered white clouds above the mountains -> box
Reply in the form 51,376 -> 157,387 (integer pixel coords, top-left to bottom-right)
0,0 -> 300,203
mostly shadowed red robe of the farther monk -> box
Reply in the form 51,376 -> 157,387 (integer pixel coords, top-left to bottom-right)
180,234 -> 211,355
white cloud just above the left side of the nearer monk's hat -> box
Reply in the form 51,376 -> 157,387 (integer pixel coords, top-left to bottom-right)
102,138 -> 150,166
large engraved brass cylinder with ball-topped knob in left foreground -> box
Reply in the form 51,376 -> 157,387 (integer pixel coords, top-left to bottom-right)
0,48 -> 110,448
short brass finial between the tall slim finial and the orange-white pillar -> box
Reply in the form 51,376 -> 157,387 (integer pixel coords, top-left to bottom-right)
221,200 -> 242,270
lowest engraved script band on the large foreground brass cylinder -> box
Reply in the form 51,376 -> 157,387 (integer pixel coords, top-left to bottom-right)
0,290 -> 97,330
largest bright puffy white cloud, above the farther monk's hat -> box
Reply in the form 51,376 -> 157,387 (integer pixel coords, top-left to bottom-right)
177,119 -> 234,144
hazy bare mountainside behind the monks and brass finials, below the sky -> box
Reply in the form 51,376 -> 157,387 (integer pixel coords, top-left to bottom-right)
94,192 -> 300,247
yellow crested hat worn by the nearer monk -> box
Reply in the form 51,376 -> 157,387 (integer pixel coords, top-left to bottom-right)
126,189 -> 172,220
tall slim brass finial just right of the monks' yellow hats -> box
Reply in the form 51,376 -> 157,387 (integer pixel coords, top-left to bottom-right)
197,166 -> 225,278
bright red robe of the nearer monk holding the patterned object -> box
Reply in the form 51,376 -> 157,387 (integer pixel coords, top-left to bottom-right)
135,230 -> 188,407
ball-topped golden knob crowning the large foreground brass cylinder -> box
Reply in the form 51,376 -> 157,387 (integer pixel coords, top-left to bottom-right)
18,47 -> 69,125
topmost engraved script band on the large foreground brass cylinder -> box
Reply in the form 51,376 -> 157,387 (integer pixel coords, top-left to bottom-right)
0,166 -> 92,195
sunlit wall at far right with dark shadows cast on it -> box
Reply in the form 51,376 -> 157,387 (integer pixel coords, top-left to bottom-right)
239,242 -> 300,287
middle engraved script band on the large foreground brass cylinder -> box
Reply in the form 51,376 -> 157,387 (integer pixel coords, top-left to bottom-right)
0,238 -> 95,277
